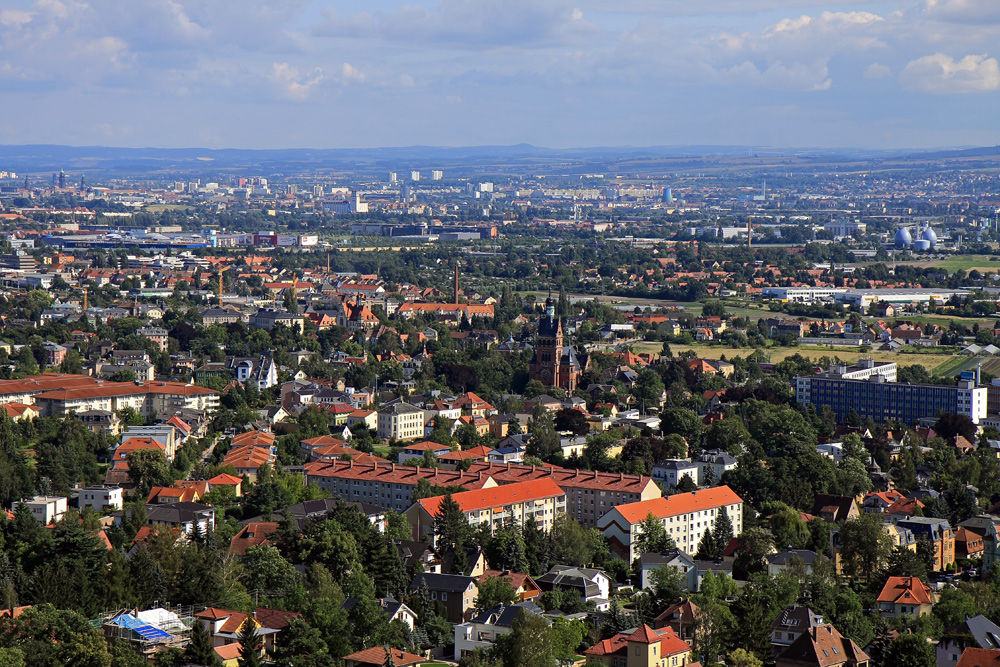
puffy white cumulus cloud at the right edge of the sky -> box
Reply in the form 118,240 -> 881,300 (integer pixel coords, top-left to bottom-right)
899,53 -> 1000,93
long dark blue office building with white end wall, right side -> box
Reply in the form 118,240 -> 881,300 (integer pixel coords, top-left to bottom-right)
795,361 -> 987,424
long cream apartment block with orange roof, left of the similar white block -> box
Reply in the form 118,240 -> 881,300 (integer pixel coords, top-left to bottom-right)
405,479 -> 566,540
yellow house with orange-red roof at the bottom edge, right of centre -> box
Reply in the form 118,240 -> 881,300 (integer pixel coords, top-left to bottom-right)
583,625 -> 691,667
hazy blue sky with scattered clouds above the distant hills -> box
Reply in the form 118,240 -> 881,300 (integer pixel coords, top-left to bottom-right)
0,0 -> 1000,148
